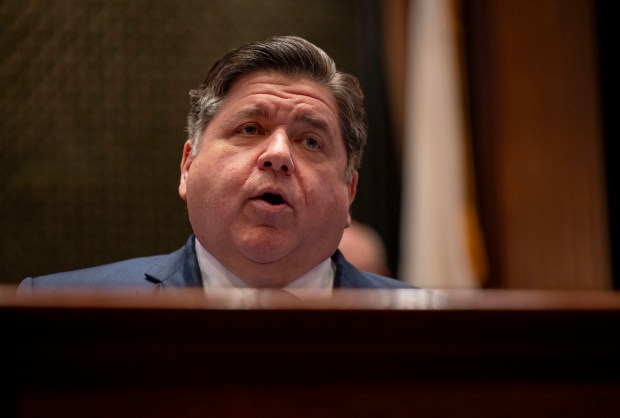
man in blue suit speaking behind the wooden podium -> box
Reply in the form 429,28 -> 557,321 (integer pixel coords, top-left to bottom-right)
19,36 -> 409,293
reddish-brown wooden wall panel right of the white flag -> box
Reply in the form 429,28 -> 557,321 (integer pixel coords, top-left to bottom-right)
467,0 -> 611,289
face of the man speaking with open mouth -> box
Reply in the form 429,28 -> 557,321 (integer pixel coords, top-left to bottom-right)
179,72 -> 357,287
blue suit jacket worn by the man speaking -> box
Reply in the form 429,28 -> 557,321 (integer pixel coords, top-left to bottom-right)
18,235 -> 412,294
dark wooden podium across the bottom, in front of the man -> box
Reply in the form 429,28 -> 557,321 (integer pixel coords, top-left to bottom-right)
0,287 -> 620,418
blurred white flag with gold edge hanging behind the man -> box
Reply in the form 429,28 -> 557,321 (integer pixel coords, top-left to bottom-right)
398,0 -> 486,288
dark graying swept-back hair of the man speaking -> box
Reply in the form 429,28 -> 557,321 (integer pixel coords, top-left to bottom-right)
187,36 -> 367,181
